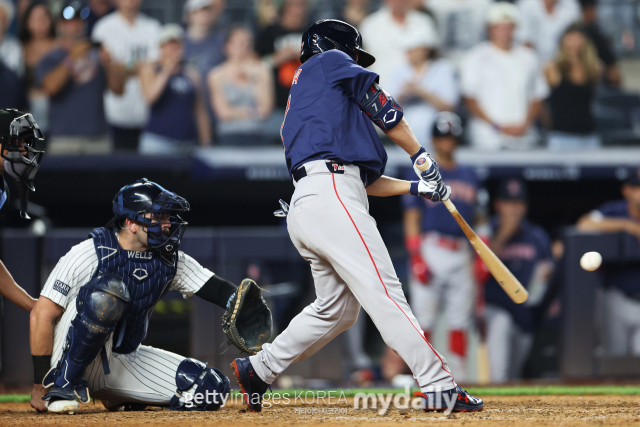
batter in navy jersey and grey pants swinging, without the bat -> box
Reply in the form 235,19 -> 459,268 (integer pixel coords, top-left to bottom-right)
232,20 -> 484,411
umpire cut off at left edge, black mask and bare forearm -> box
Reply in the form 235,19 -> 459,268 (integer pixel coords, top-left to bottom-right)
0,109 -> 44,312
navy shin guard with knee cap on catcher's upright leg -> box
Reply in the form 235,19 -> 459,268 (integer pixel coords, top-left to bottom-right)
43,274 -> 130,387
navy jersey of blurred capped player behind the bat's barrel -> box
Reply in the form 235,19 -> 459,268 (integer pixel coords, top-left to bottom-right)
484,217 -> 552,332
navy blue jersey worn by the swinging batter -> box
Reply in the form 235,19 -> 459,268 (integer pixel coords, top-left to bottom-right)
280,50 -> 387,184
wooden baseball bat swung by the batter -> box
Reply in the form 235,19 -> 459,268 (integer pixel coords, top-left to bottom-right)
443,200 -> 529,304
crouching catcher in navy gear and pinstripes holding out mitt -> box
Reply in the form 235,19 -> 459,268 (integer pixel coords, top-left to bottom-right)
30,179 -> 272,413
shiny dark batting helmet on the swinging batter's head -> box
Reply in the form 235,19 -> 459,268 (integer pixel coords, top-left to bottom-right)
300,19 -> 376,68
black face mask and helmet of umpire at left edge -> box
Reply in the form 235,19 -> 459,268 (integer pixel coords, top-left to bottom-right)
0,108 -> 44,219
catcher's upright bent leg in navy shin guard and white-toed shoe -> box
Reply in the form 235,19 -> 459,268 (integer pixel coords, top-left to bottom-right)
42,274 -> 129,413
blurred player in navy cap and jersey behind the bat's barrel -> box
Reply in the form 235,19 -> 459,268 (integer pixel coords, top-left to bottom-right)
484,179 -> 553,383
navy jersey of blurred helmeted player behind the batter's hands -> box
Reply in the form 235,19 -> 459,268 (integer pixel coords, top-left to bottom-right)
402,165 -> 479,237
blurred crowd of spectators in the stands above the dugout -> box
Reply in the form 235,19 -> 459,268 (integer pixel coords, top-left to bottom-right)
0,0 -> 632,155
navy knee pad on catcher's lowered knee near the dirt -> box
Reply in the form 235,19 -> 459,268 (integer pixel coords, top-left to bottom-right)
169,359 -> 230,411
